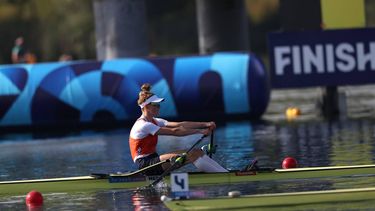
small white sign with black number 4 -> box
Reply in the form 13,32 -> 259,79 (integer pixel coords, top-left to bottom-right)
171,173 -> 189,198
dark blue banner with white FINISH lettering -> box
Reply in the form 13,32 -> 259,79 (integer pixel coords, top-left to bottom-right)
268,28 -> 375,88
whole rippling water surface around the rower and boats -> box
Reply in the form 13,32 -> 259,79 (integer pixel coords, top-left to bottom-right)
0,86 -> 375,210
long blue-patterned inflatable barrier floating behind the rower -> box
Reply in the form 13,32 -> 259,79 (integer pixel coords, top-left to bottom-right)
0,53 -> 269,126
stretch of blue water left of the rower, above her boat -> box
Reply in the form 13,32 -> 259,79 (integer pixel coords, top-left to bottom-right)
0,132 -> 135,180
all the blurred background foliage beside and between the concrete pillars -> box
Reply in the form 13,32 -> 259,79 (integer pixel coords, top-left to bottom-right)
0,0 -> 375,64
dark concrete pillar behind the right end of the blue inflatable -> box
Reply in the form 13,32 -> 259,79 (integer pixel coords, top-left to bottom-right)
196,0 -> 249,54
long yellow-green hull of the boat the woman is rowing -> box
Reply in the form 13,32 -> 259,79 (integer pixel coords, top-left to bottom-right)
0,164 -> 375,196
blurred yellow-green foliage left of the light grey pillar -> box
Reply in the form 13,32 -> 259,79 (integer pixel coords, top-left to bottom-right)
0,0 -> 95,63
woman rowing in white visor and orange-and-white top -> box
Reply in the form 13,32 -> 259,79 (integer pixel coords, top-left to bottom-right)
129,84 -> 227,175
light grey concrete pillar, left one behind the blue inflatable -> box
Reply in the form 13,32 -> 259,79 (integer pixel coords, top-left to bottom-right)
93,0 -> 149,60
